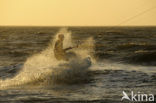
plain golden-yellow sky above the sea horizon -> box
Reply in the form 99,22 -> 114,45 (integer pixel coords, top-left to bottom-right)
0,0 -> 156,26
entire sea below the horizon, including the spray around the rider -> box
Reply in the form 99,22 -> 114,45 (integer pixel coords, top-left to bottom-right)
0,27 -> 156,103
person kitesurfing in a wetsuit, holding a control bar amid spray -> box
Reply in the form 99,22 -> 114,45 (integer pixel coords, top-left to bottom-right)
54,34 -> 78,61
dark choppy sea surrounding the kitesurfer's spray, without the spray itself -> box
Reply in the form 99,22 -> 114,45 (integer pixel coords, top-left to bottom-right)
0,27 -> 156,103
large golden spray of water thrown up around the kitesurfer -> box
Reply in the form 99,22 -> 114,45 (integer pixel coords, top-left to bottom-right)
0,28 -> 94,88
